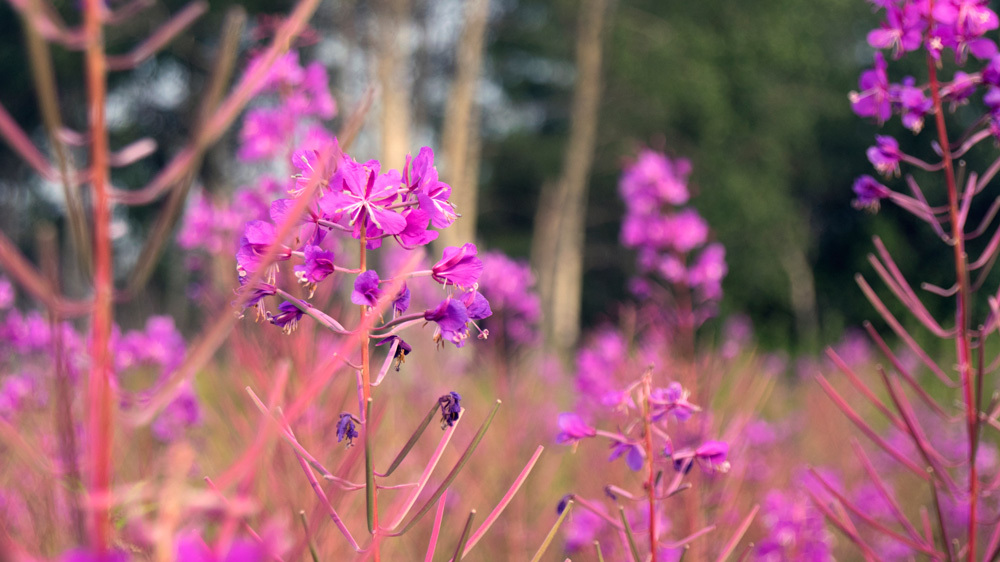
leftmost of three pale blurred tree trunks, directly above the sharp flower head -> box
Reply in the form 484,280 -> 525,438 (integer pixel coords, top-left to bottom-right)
375,0 -> 410,170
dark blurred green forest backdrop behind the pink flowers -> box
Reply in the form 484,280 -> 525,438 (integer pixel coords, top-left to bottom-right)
0,0 -> 947,352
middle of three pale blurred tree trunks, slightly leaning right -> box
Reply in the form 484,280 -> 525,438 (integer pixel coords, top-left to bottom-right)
439,0 -> 490,246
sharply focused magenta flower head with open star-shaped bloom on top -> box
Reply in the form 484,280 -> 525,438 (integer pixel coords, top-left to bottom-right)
236,141 -> 492,347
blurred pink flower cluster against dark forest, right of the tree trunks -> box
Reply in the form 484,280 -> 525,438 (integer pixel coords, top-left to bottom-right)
618,149 -> 728,325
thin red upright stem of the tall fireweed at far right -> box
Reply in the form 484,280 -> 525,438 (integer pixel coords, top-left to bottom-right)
927,9 -> 979,560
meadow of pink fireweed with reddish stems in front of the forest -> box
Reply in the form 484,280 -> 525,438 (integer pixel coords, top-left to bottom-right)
0,0 -> 1000,562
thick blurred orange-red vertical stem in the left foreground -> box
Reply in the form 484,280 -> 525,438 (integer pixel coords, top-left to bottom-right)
83,0 -> 113,552
